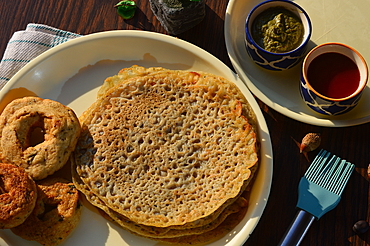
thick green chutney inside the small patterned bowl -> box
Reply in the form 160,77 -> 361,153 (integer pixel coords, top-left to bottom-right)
252,7 -> 304,53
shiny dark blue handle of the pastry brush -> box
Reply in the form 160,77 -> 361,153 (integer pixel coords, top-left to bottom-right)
279,210 -> 316,246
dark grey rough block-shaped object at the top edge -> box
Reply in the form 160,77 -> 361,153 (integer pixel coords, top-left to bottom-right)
149,0 -> 205,35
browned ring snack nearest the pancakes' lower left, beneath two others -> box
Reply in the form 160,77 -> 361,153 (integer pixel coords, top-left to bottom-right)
11,178 -> 81,246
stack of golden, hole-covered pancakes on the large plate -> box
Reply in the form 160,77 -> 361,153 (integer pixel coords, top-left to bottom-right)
72,66 -> 258,244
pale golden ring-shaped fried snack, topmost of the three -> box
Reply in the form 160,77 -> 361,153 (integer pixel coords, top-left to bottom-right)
0,97 -> 81,180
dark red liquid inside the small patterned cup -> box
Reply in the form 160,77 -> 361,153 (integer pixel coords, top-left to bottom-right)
307,52 -> 360,98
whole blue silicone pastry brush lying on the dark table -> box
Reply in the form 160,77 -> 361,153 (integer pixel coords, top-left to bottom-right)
279,150 -> 354,246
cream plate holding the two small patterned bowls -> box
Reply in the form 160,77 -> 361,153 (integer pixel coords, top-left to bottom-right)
225,0 -> 370,127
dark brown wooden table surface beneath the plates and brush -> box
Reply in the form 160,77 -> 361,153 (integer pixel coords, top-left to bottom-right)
0,0 -> 370,246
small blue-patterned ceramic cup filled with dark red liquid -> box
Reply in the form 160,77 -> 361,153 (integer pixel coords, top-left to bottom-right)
300,43 -> 368,115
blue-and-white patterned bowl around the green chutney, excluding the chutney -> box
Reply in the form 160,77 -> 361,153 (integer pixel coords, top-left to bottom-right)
245,0 -> 312,71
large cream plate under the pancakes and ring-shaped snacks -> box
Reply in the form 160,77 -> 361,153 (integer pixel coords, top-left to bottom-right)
0,31 -> 272,246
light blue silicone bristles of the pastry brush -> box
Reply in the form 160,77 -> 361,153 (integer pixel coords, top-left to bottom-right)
304,150 -> 354,196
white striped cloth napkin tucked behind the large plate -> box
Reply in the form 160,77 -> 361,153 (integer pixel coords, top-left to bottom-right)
0,23 -> 81,89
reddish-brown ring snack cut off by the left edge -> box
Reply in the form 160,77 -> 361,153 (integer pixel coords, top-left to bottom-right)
0,163 -> 37,229
